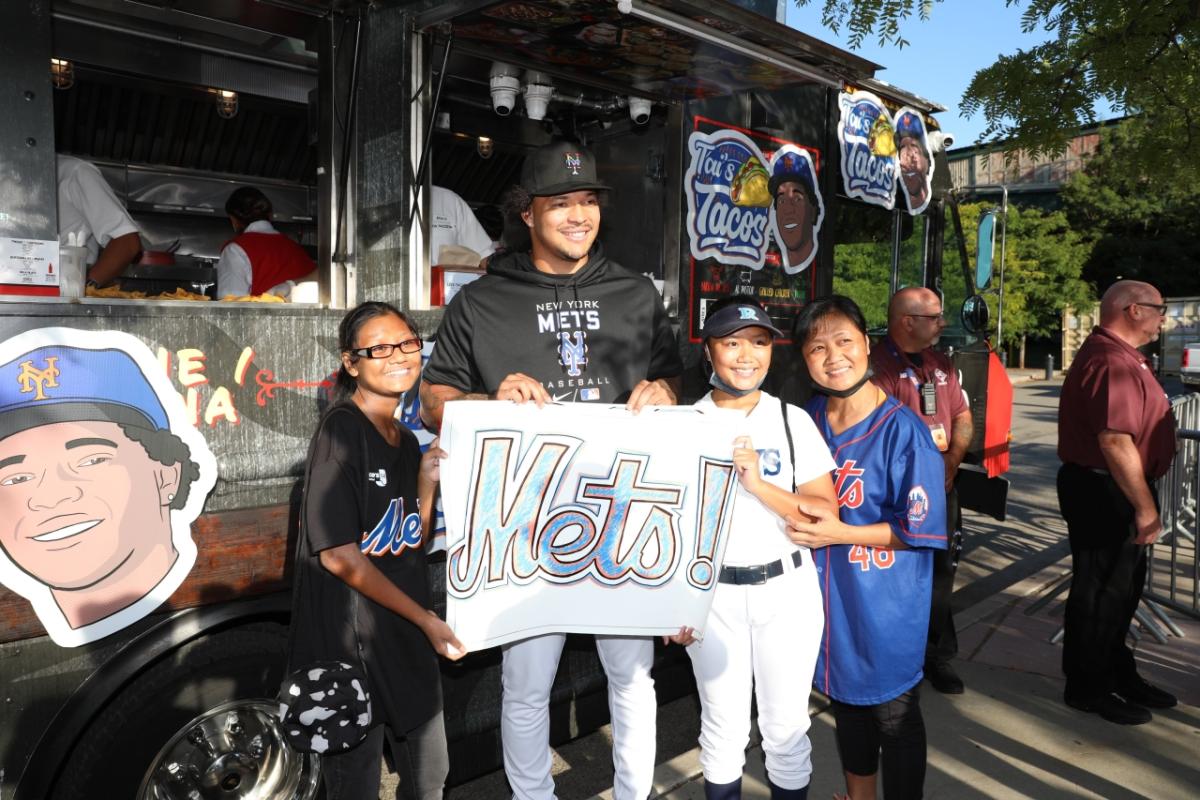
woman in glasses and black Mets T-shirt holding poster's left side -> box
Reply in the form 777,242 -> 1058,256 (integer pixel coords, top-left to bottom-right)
290,302 -> 464,800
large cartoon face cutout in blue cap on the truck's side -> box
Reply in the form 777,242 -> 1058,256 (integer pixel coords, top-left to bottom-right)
0,329 -> 216,646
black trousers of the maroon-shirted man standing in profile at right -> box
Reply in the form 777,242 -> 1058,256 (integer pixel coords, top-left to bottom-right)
1058,464 -> 1158,699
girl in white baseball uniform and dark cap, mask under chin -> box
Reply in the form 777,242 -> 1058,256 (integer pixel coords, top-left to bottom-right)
671,297 -> 836,800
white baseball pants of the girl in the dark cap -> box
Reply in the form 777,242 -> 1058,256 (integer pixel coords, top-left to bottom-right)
688,561 -> 824,789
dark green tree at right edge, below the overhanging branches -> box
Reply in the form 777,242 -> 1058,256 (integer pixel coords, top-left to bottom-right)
1062,121 -> 1200,296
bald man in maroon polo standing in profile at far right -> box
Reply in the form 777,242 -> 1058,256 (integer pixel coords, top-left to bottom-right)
1058,281 -> 1176,724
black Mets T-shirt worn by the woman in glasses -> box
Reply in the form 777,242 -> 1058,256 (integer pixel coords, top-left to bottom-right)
292,403 -> 442,734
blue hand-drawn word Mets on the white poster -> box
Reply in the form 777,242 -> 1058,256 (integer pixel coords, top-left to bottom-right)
448,431 -> 733,597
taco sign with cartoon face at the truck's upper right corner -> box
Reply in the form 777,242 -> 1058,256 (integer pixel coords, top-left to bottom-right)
838,91 -> 934,213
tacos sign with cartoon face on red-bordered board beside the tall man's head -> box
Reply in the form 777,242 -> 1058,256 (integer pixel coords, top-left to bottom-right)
684,130 -> 824,273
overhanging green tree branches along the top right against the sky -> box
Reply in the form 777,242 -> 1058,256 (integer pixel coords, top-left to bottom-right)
796,0 -> 1200,180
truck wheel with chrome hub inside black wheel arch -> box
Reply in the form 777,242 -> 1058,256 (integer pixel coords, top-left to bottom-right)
53,624 -> 320,800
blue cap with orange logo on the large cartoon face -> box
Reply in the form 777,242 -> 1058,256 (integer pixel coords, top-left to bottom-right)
0,344 -> 170,439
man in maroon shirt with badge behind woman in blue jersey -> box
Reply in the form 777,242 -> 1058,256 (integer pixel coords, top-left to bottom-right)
871,287 -> 974,694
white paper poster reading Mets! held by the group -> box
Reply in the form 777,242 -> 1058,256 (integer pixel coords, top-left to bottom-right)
442,401 -> 737,650
